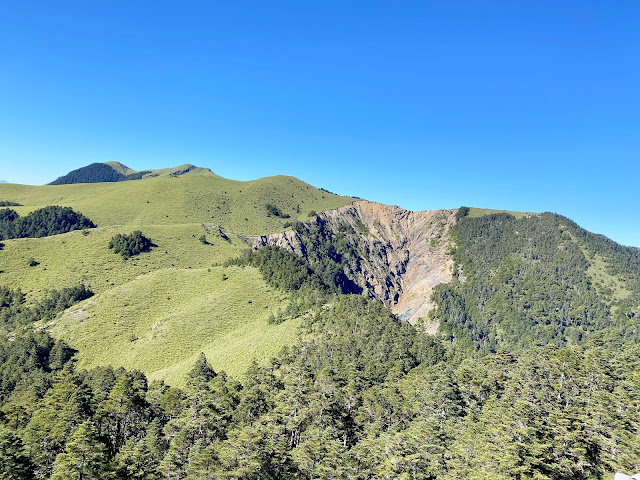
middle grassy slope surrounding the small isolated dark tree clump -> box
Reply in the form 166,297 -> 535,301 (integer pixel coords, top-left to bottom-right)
0,224 -> 243,298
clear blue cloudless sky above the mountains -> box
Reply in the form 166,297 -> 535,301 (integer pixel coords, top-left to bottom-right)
0,0 -> 640,246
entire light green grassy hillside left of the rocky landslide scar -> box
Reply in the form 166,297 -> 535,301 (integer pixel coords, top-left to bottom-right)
0,173 -> 353,384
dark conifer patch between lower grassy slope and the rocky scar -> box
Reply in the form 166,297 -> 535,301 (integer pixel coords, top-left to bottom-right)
226,246 -> 331,291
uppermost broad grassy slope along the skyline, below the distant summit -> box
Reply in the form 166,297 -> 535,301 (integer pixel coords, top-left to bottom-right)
0,175 -> 353,235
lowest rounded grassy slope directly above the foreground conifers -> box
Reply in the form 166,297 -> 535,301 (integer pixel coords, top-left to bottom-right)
51,267 -> 297,384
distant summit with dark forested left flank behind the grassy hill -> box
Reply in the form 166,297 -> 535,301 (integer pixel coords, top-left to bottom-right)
49,162 -> 215,185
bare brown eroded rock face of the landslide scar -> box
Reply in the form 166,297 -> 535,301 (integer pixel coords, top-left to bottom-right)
250,201 -> 457,329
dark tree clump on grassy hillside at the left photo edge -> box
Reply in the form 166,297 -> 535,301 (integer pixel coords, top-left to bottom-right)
0,205 -> 95,240
